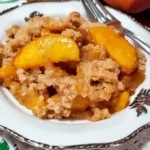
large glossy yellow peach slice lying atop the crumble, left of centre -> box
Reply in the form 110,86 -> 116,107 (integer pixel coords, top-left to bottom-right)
13,34 -> 80,69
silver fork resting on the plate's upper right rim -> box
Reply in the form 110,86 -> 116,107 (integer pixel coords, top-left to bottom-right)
82,0 -> 150,54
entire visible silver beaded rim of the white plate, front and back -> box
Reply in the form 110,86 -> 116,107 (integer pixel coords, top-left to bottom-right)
0,1 -> 150,149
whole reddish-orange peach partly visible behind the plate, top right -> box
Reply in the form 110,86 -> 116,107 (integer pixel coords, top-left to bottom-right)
104,0 -> 150,13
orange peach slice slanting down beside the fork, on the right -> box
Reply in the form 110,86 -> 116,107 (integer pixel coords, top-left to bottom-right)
89,27 -> 137,74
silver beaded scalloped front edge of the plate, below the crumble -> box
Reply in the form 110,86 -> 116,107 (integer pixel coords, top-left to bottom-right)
0,122 -> 150,149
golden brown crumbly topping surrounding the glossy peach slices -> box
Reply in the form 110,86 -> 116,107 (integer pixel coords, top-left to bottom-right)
0,12 -> 146,121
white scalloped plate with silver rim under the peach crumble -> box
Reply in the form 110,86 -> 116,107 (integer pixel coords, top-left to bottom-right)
0,1 -> 150,149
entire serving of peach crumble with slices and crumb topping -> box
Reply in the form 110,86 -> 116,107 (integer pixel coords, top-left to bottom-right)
0,12 -> 146,121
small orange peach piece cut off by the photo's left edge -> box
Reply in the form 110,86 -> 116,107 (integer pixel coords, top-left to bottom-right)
0,65 -> 17,80
